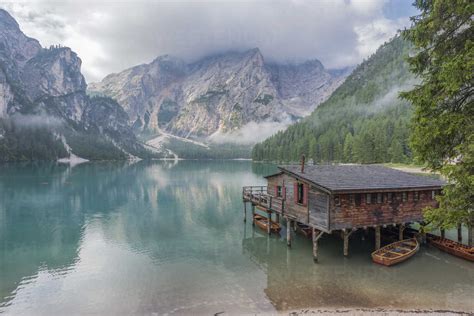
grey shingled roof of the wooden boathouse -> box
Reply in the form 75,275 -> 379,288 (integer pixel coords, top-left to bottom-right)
278,165 -> 446,192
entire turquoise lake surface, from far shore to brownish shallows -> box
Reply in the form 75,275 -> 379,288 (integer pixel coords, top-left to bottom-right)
0,161 -> 474,315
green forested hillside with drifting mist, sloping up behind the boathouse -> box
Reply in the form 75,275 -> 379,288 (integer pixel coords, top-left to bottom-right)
252,37 -> 415,163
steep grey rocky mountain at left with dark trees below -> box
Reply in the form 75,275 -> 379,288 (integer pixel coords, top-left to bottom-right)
0,9 -> 162,161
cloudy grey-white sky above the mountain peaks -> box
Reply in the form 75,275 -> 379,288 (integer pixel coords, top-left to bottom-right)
0,0 -> 416,82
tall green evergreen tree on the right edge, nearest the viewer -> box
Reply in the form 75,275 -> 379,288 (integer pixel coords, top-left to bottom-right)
402,0 -> 474,244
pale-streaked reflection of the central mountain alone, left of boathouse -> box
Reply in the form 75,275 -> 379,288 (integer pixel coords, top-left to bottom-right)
96,161 -> 265,262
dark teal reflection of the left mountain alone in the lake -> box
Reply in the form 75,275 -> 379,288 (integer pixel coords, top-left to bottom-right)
0,162 -> 159,304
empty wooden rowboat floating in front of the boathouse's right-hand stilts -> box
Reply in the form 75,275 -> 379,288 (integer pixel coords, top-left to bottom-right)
372,238 -> 420,266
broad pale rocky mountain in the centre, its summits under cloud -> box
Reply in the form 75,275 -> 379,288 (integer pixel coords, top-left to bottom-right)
89,48 -> 347,142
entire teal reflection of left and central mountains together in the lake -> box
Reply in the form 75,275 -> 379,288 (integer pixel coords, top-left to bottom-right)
0,161 -> 274,306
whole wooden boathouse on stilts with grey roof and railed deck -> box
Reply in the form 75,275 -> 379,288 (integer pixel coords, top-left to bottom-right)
242,160 -> 445,262
